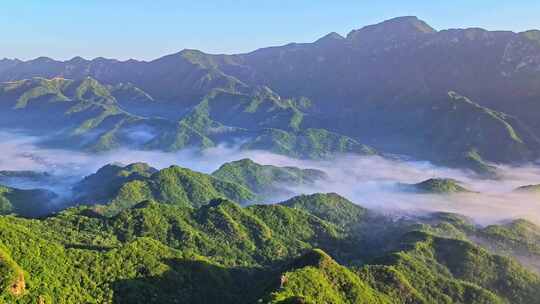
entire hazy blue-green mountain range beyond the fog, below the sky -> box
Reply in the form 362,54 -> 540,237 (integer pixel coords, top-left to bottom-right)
0,17 -> 540,173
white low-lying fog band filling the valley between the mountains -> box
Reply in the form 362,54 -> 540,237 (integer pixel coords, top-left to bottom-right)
0,132 -> 540,224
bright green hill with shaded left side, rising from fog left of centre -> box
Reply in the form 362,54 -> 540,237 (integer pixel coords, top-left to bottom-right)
74,163 -> 256,215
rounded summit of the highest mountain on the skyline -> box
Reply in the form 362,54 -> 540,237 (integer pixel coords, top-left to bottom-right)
347,16 -> 436,41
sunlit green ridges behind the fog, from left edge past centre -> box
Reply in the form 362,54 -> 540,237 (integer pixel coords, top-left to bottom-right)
0,77 -> 372,158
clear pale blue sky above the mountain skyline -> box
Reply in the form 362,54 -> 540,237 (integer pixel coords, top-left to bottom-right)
4,0 -> 540,60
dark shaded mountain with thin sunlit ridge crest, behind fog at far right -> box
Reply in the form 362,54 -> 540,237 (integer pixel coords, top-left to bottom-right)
419,92 -> 539,173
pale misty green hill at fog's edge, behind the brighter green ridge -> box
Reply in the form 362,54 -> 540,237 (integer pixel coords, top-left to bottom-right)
212,159 -> 328,198
